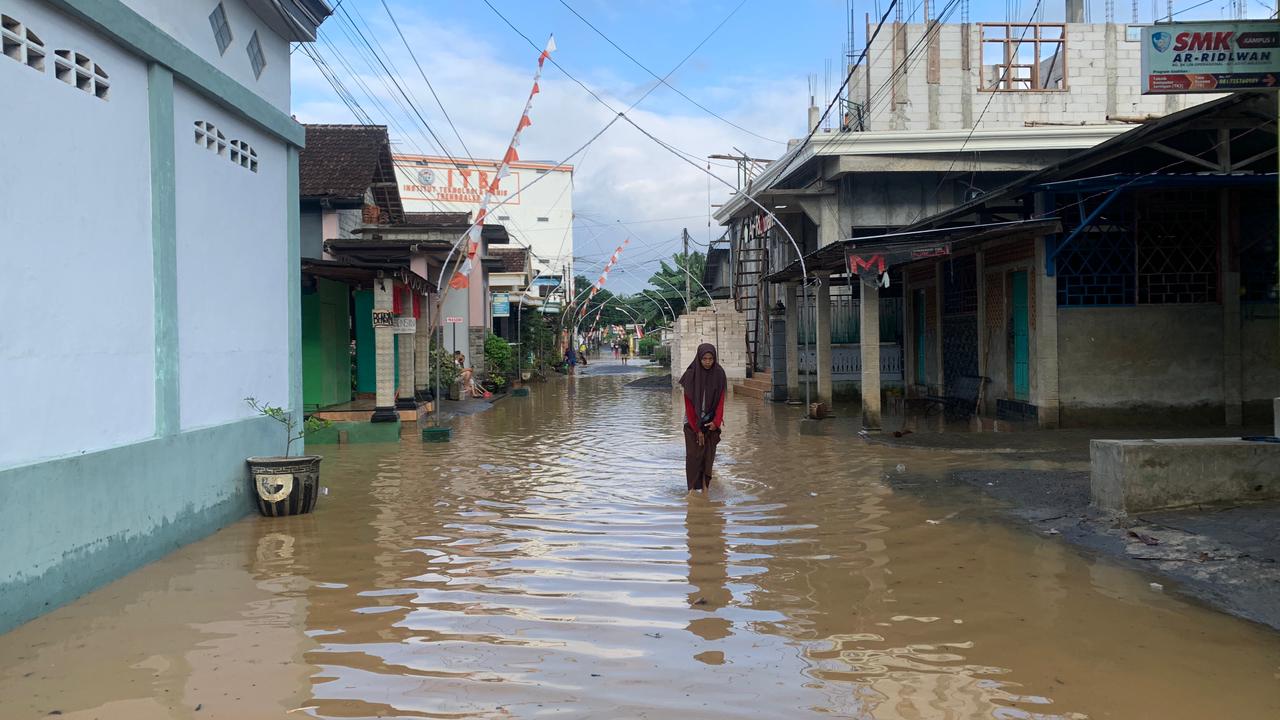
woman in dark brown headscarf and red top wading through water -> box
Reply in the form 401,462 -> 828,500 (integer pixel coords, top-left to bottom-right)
680,342 -> 728,492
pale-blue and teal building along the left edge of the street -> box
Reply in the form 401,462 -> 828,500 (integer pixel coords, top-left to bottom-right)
0,0 -> 330,630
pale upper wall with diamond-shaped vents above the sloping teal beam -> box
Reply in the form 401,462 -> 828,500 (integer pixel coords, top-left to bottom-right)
120,0 -> 289,113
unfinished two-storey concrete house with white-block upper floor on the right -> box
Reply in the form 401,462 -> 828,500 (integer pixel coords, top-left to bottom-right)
716,3 -> 1208,415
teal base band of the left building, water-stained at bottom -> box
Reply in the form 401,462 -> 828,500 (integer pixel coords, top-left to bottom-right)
0,418 -> 284,633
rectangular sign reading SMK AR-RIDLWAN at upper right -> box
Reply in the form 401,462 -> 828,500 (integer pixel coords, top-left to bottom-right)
1142,20 -> 1280,95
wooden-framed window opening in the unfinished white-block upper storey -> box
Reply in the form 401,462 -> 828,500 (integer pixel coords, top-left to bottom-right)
978,23 -> 1066,92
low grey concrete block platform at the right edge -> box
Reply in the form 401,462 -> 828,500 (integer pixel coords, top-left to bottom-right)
1089,438 -> 1280,515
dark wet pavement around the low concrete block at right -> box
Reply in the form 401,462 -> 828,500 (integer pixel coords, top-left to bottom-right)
867,428 -> 1280,630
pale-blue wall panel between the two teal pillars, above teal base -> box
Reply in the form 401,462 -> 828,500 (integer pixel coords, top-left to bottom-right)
174,83 -> 286,429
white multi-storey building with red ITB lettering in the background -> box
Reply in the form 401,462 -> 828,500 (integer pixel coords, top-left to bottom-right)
396,155 -> 573,294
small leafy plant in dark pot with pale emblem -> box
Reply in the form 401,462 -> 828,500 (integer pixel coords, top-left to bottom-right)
244,397 -> 330,518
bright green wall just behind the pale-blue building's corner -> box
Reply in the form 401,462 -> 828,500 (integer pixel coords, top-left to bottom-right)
302,278 -> 351,411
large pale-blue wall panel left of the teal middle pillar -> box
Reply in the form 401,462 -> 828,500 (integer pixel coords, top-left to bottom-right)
0,0 -> 155,468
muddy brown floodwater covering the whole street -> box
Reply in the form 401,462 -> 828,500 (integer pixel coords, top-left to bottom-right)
0,364 -> 1280,720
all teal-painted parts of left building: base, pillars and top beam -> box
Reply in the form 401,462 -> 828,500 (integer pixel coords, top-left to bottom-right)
0,0 -> 305,633
